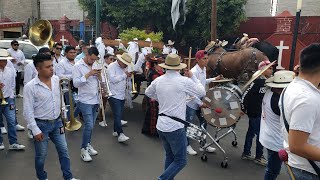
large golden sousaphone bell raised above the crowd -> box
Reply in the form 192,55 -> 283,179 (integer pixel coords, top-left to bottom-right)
29,20 -> 54,49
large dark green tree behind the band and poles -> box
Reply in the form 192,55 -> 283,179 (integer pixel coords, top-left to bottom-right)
78,0 -> 246,49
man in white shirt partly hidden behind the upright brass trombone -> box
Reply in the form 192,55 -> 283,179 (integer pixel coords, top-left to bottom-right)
55,46 -> 79,120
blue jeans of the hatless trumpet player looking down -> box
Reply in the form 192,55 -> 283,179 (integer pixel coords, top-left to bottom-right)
78,102 -> 99,148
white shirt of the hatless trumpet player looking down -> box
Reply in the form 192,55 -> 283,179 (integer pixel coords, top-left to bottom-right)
72,59 -> 99,104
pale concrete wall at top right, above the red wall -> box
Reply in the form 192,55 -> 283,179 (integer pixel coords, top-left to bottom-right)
245,0 -> 320,17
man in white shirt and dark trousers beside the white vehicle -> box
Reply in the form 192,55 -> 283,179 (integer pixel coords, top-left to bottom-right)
8,40 -> 26,98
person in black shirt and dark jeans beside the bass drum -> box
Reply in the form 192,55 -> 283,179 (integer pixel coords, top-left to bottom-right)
241,60 -> 273,166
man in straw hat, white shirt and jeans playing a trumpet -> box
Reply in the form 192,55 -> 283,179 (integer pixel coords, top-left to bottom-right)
107,53 -> 132,142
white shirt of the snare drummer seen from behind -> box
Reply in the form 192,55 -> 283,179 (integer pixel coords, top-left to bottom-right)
145,70 -> 206,132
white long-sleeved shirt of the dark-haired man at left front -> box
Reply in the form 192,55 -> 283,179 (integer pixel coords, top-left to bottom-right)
23,75 -> 61,135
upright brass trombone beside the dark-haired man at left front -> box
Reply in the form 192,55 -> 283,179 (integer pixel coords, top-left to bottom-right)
60,78 -> 82,131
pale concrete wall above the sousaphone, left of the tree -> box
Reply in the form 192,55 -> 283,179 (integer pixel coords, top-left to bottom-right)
40,0 -> 83,20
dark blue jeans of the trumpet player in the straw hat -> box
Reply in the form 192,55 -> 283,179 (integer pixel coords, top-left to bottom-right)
108,97 -> 124,134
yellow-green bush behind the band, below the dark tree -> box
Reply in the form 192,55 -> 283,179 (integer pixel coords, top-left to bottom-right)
119,27 -> 163,42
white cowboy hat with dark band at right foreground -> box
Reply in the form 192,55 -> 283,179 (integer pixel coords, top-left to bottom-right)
266,70 -> 295,88
